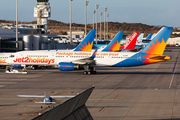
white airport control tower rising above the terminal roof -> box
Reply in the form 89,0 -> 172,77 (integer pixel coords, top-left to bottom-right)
34,0 -> 51,31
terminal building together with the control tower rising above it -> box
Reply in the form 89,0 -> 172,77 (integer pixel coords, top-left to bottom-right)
0,0 -> 84,52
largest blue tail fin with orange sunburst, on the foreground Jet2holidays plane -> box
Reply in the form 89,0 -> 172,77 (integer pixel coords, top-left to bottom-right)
140,27 -> 173,55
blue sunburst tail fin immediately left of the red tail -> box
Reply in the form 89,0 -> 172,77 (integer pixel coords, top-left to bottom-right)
102,31 -> 123,52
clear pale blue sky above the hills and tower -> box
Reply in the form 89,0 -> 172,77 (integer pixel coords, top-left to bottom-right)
0,0 -> 180,27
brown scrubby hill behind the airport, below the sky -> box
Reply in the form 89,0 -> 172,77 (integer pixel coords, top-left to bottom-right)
0,20 -> 180,39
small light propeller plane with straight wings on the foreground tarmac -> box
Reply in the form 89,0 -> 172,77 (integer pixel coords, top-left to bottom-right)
17,93 -> 74,104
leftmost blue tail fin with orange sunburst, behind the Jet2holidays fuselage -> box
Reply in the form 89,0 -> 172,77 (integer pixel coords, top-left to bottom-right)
74,30 -> 96,52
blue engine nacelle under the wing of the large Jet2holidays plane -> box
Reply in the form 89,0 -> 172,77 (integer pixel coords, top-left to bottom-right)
59,62 -> 79,71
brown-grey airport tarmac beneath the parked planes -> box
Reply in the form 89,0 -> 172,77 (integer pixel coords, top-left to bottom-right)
0,47 -> 180,120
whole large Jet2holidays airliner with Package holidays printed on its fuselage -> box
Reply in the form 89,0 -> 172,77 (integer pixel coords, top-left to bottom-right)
0,27 -> 173,74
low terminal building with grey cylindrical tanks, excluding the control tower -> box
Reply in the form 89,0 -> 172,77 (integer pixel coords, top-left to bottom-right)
0,27 -> 83,52
